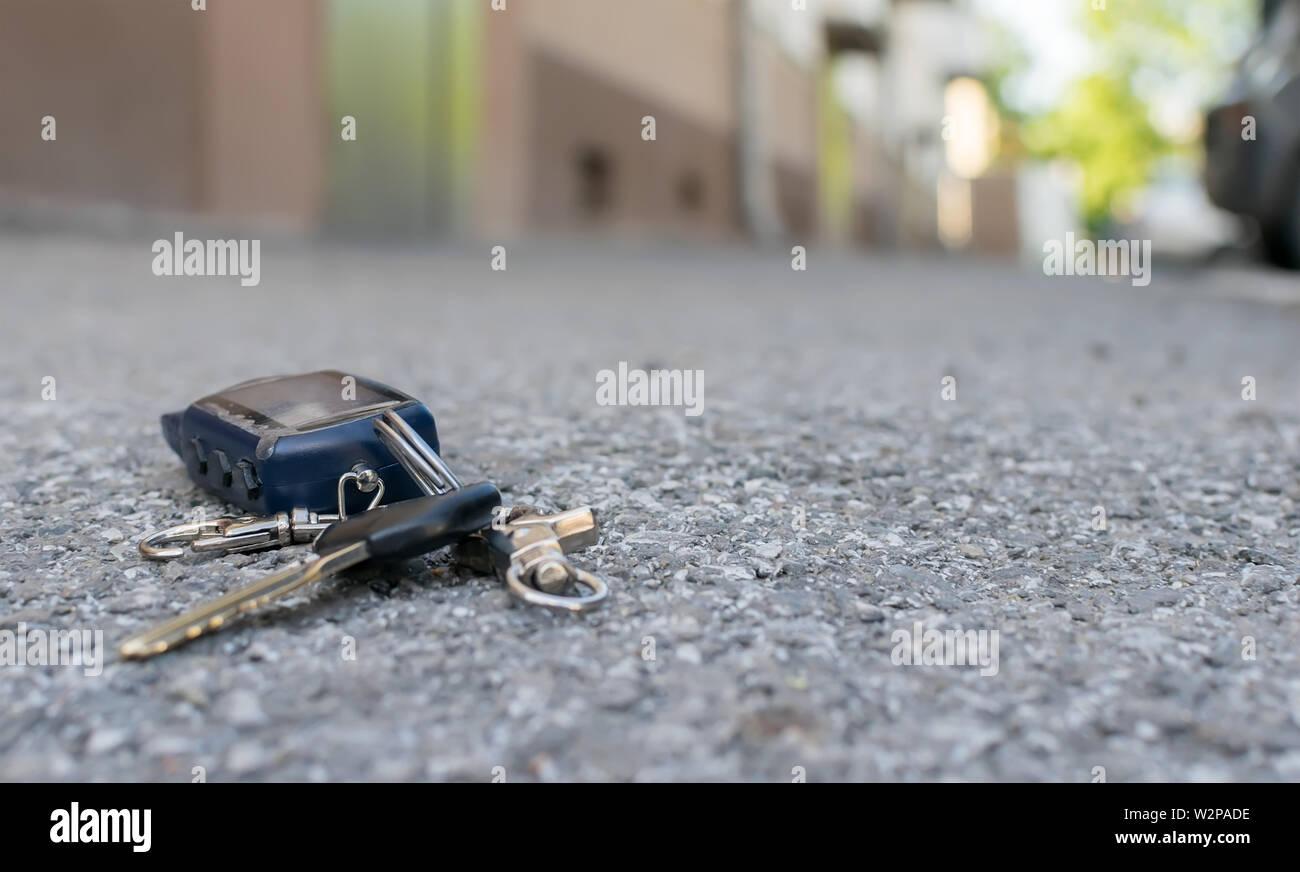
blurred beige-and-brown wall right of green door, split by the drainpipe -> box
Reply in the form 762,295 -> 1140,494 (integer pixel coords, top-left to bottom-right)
477,0 -> 818,237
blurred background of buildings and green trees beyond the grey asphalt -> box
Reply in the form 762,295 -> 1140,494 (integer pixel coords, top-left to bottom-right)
0,0 -> 1300,265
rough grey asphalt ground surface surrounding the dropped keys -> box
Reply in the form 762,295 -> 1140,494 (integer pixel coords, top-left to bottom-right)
0,235 -> 1300,781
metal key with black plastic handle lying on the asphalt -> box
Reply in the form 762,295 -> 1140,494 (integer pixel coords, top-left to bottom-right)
120,482 -> 501,658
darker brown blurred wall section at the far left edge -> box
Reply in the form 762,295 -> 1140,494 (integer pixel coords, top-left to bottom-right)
0,0 -> 203,209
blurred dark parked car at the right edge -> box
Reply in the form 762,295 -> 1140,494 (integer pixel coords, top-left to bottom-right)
1205,0 -> 1300,269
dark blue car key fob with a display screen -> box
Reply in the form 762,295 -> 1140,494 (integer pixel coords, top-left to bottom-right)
163,370 -> 438,515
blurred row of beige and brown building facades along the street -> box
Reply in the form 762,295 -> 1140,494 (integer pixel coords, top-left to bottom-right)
0,0 -> 1014,247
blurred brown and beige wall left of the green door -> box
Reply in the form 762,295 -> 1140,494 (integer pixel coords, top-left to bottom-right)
0,0 -> 324,226
